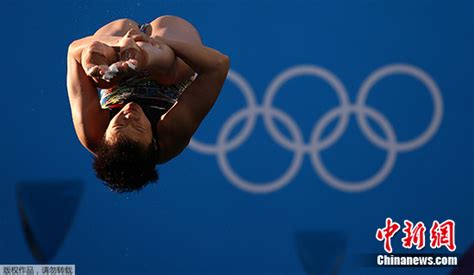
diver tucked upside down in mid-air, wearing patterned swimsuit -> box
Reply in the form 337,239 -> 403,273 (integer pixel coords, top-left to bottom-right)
67,16 -> 229,192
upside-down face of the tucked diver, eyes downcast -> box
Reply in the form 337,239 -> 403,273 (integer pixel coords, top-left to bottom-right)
105,102 -> 153,146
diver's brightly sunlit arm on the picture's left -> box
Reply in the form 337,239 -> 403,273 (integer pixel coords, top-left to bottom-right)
67,40 -> 109,153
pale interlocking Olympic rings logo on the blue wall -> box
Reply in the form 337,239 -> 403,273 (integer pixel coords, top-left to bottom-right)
190,64 -> 443,193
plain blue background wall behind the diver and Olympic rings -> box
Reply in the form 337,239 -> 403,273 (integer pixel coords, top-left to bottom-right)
0,0 -> 474,274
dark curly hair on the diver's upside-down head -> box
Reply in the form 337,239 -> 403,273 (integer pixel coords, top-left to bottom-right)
92,138 -> 159,193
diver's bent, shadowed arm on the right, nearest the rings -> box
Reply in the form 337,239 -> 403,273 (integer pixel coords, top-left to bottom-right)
154,39 -> 230,163
